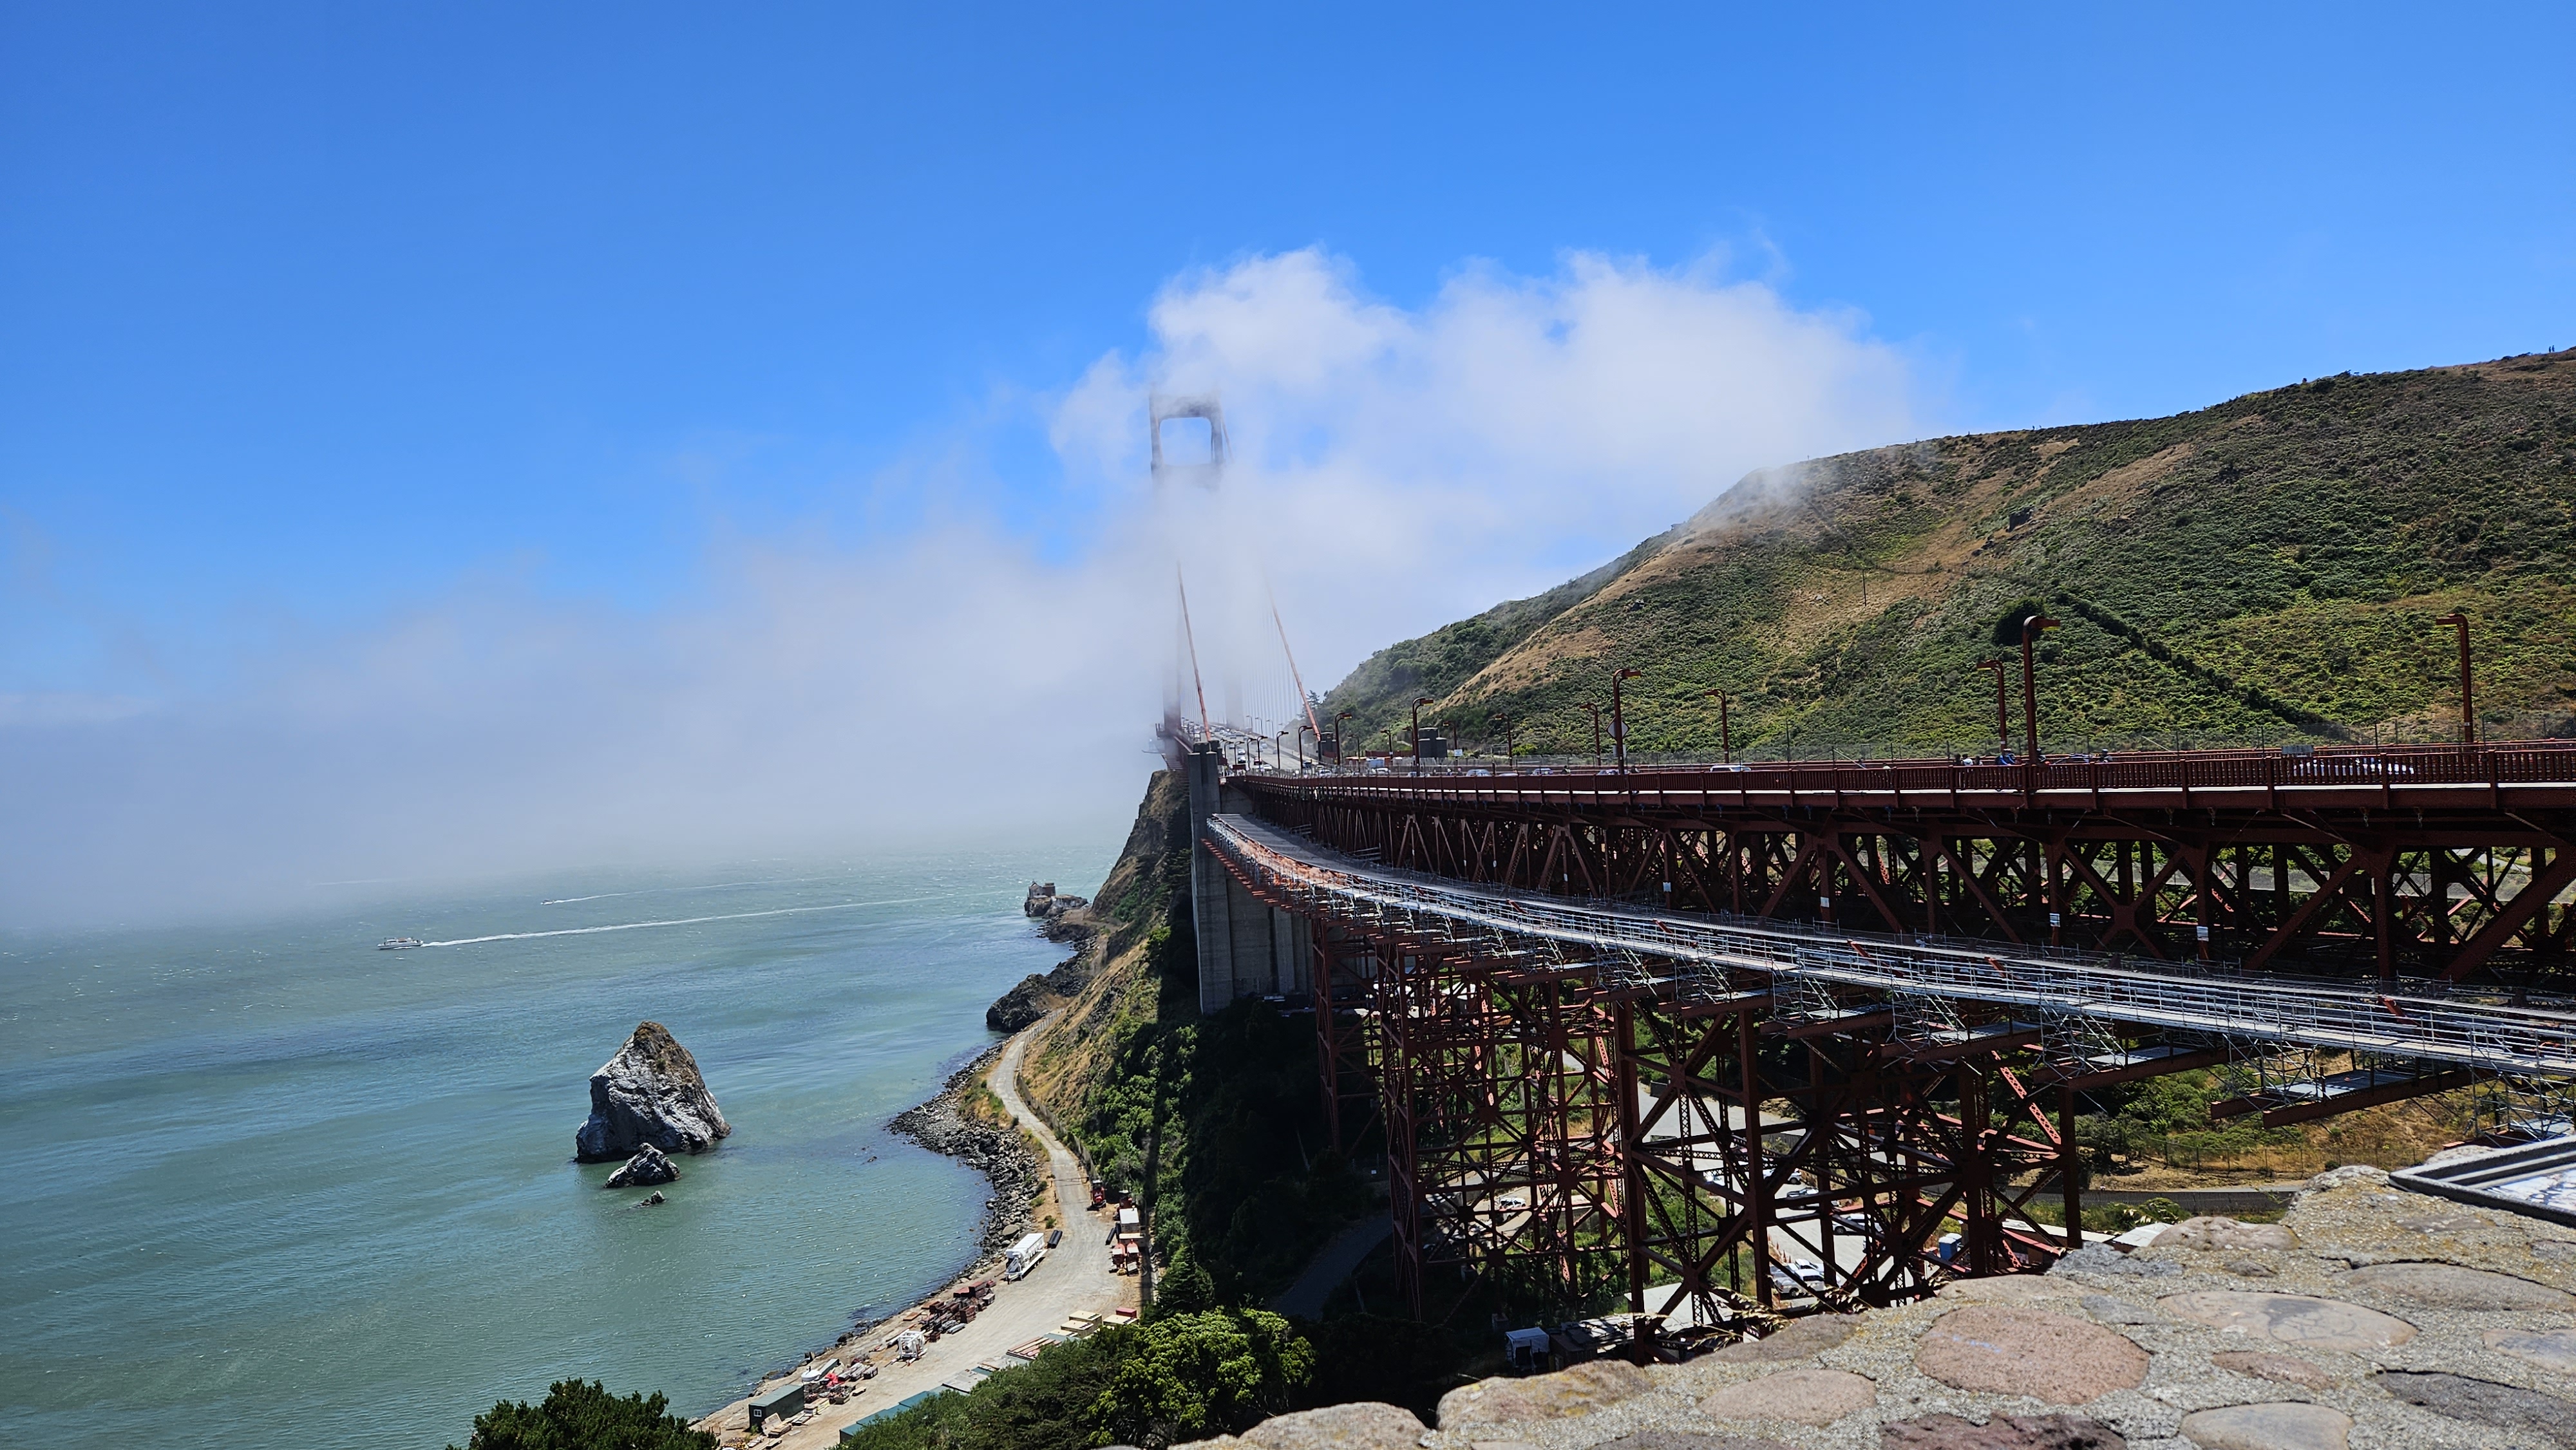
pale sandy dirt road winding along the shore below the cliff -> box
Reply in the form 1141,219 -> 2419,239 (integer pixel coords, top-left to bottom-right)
696,1017 -> 1136,1450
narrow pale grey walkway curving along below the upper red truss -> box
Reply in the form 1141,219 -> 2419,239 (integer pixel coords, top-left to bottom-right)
1206,819 -> 2576,1079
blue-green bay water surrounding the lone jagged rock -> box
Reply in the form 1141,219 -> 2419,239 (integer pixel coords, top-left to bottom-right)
0,850 -> 1108,1450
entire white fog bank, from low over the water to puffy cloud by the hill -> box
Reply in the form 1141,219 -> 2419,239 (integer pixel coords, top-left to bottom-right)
0,250 -> 1914,925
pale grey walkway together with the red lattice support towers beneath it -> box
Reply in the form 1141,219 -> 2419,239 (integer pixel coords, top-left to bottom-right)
1198,811 -> 2576,1326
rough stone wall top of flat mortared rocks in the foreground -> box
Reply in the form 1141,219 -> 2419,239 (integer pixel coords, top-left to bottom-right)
1180,1169 -> 2576,1450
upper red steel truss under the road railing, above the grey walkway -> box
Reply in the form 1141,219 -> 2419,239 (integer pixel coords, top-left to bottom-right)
1234,742 -> 2576,984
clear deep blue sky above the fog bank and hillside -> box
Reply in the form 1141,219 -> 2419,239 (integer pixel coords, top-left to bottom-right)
0,3 -> 2576,917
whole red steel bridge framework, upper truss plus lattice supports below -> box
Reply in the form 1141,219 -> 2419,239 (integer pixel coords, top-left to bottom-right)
1203,747 -> 2576,1324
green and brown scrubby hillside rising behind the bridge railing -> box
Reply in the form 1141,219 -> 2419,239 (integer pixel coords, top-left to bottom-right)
1324,353 -> 2576,757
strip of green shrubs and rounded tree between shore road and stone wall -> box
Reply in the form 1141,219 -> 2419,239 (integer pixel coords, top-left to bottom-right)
850,1308 -> 1314,1450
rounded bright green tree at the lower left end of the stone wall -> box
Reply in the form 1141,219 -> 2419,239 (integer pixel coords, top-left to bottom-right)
1090,1308 -> 1314,1450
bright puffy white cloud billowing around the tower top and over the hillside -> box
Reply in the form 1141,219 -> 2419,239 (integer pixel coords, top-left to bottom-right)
1056,250 -> 1917,683
